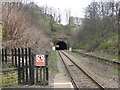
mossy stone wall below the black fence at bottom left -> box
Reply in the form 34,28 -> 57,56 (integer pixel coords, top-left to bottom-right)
0,69 -> 18,87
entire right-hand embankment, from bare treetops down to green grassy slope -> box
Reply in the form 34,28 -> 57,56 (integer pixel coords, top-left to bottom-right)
71,1 -> 120,55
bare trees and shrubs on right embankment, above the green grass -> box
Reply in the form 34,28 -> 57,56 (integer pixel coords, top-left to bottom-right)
73,1 -> 120,51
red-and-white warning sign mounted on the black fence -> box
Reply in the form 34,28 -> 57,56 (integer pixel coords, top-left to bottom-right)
35,55 -> 45,66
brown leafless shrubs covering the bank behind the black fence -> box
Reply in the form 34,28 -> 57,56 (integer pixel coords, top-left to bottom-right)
2,2 -> 50,52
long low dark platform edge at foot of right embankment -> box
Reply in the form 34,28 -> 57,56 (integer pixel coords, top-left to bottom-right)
72,51 -> 120,69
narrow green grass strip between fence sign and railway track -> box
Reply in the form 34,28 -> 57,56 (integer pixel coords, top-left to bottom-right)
48,51 -> 58,72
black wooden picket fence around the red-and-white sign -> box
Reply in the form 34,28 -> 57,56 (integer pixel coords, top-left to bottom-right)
2,48 -> 48,84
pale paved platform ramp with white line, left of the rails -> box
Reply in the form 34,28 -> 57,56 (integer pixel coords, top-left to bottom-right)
54,52 -> 74,90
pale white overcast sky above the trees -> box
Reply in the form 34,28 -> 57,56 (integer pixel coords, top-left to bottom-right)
33,0 -> 118,22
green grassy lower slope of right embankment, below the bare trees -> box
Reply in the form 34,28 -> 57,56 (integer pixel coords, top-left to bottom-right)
72,32 -> 119,61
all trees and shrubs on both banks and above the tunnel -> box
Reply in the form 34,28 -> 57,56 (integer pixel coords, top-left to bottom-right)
2,1 -> 120,55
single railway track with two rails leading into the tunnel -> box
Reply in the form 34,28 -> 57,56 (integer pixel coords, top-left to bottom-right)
58,51 -> 105,90
